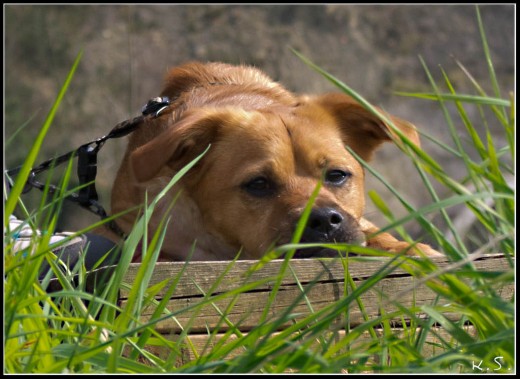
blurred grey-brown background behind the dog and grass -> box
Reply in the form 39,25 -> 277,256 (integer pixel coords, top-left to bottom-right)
4,4 -> 515,246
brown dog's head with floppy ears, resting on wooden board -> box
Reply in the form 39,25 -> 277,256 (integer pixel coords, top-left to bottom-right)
129,88 -> 418,259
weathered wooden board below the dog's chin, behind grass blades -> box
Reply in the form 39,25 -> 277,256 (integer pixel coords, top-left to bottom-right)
121,255 -> 514,335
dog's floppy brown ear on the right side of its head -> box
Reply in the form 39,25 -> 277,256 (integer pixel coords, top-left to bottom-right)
315,93 -> 420,160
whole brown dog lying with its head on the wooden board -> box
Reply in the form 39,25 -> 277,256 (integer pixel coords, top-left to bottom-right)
112,63 -> 439,260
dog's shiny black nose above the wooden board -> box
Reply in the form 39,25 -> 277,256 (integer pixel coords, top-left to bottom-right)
304,208 -> 344,242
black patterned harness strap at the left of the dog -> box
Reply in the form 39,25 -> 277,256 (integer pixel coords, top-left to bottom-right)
5,97 -> 171,237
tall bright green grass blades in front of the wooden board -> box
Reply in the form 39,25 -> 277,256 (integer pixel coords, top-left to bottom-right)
4,8 -> 515,373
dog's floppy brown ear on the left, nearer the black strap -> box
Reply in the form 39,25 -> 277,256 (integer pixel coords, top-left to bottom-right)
130,112 -> 218,182
